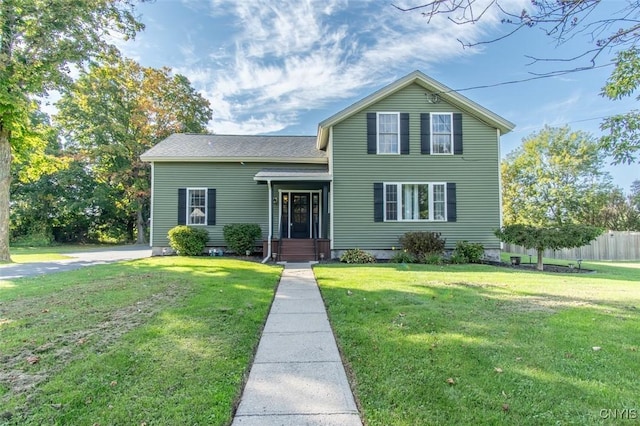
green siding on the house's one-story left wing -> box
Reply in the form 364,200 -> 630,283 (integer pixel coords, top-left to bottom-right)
152,162 -> 326,247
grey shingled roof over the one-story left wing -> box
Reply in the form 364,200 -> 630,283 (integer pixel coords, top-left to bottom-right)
140,133 -> 327,164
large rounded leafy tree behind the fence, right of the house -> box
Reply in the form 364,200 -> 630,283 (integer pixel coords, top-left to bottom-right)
501,127 -> 612,227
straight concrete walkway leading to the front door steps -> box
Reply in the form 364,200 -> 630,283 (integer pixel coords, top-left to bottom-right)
232,263 -> 362,426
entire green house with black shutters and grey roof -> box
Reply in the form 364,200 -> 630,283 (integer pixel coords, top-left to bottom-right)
142,71 -> 514,260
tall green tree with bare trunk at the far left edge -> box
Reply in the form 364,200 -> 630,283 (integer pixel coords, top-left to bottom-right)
0,0 -> 142,261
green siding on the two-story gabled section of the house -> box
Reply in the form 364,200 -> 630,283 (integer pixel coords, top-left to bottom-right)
332,84 -> 500,250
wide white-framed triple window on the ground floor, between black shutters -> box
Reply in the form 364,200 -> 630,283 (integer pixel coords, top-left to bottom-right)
384,182 -> 447,222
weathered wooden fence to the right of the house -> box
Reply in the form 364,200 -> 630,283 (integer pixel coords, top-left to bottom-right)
503,231 -> 640,260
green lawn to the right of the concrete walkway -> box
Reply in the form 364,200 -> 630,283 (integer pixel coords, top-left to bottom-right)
314,263 -> 640,426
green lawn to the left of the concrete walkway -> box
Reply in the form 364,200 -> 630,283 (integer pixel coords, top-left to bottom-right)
0,257 -> 280,425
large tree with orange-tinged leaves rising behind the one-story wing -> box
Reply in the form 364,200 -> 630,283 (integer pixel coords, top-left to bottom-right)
56,58 -> 212,243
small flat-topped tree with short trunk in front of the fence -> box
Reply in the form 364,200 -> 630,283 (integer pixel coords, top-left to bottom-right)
495,224 -> 602,271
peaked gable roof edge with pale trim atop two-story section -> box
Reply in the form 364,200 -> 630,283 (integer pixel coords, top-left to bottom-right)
317,71 -> 515,149
